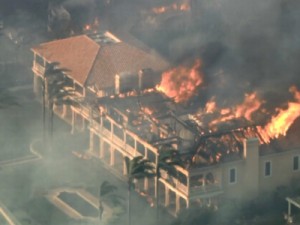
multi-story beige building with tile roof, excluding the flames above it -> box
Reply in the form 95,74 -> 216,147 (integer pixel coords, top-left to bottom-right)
32,32 -> 300,212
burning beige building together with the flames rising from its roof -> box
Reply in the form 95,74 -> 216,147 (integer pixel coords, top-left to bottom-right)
32,32 -> 300,213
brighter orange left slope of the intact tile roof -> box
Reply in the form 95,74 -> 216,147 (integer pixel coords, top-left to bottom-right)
32,35 -> 100,85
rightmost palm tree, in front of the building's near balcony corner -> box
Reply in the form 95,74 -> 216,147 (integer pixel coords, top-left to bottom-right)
155,145 -> 183,224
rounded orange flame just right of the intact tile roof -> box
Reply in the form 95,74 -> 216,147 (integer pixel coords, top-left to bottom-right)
156,59 -> 203,102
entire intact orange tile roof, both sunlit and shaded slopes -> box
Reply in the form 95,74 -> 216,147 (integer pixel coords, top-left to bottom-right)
32,35 -> 168,90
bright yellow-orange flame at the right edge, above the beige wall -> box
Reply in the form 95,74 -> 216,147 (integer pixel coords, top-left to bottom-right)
258,86 -> 300,143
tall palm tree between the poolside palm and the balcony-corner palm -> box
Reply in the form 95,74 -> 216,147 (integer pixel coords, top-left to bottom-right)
125,156 -> 155,225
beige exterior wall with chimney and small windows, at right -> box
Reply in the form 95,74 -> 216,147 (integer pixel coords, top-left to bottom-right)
192,140 -> 300,202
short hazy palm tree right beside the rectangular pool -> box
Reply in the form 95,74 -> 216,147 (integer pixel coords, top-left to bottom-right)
99,181 -> 124,220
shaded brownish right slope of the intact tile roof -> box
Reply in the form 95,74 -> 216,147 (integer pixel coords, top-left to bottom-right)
87,42 -> 168,89
